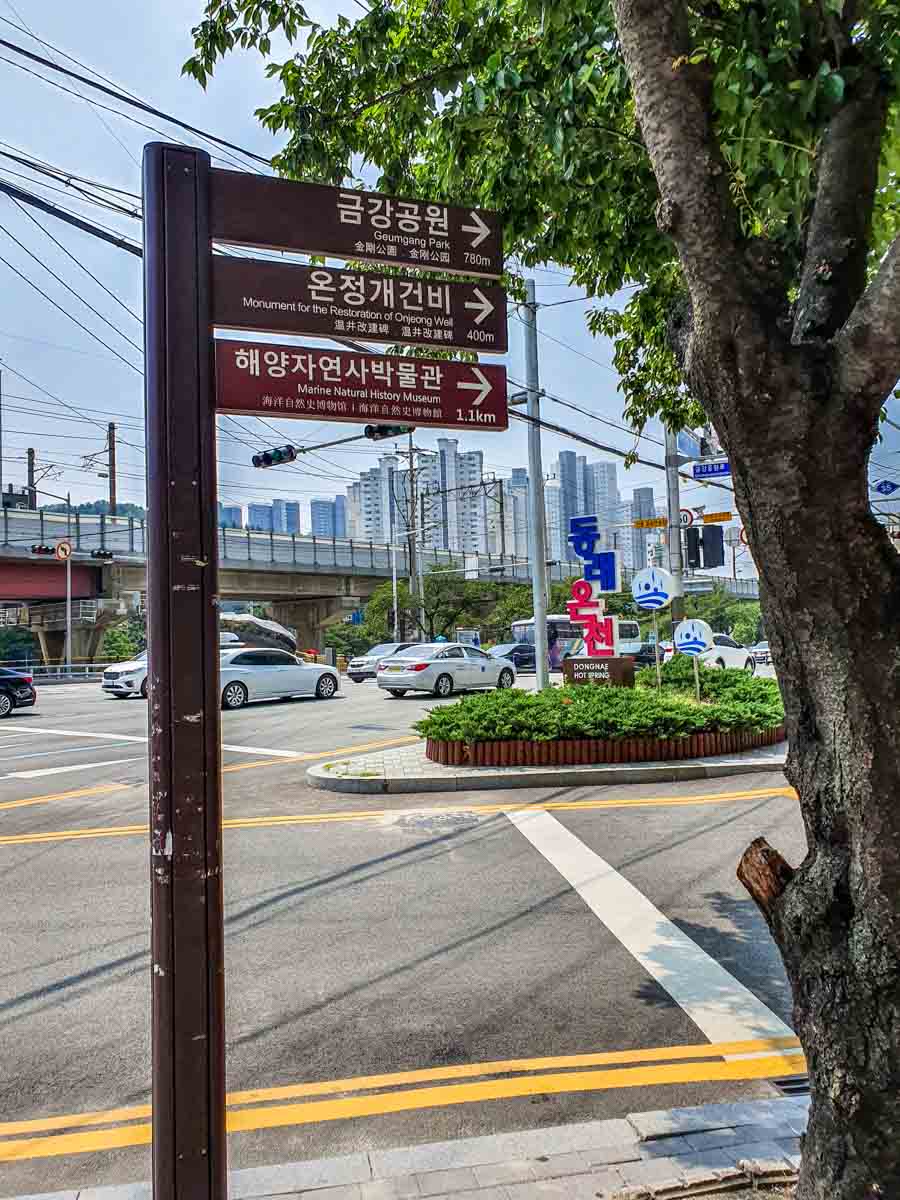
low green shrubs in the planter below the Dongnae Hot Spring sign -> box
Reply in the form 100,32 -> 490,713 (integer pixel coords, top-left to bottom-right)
415,671 -> 784,742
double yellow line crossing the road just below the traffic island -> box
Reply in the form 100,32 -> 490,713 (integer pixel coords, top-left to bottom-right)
0,782 -> 794,846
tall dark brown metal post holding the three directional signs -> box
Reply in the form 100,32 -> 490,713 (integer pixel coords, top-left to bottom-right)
144,143 -> 228,1200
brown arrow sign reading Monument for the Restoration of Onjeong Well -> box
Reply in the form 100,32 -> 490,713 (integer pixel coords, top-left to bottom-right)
212,254 -> 506,354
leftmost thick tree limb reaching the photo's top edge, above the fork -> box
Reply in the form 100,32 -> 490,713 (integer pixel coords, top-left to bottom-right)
613,0 -> 749,311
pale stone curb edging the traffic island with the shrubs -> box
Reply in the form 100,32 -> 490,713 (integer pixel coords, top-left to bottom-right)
306,755 -> 785,796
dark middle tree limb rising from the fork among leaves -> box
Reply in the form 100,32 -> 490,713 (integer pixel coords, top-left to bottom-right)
793,70 -> 888,342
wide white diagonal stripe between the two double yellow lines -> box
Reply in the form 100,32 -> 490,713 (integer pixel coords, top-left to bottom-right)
506,811 -> 793,1042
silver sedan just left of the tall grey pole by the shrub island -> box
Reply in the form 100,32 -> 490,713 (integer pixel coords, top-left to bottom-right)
377,642 -> 516,697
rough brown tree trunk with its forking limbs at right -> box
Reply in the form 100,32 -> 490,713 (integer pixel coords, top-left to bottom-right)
613,0 -> 900,1200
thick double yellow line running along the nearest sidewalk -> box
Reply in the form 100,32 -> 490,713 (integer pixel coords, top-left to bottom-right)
0,1038 -> 805,1162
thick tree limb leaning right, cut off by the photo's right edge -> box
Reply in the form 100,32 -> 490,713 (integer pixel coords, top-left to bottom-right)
834,235 -> 900,416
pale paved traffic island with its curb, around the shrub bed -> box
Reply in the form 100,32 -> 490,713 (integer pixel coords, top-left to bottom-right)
306,742 -> 785,794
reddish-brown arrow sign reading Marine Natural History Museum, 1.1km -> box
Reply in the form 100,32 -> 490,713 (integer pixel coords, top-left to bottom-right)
216,338 -> 509,432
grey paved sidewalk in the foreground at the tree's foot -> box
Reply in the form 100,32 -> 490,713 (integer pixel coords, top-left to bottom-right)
19,1098 -> 809,1200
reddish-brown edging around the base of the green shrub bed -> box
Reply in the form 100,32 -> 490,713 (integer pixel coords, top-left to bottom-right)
425,725 -> 785,767
